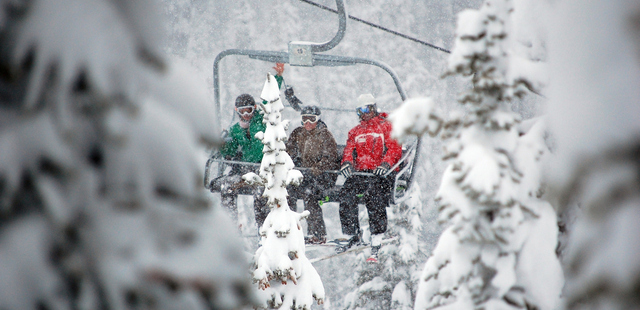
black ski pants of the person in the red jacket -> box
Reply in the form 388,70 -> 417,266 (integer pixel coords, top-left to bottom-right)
338,174 -> 393,236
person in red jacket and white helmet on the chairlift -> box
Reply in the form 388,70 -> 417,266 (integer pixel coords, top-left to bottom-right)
336,94 -> 402,259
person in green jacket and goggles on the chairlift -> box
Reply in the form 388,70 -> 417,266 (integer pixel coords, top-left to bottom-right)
220,94 -> 269,227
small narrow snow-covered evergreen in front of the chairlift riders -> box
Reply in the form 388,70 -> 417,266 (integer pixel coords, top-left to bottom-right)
243,73 -> 325,310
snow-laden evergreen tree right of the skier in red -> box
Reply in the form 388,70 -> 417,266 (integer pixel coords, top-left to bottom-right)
394,0 -> 562,309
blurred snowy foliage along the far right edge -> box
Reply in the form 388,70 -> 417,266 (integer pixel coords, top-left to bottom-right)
548,0 -> 640,309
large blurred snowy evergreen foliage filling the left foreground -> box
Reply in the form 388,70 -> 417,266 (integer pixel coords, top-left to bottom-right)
0,0 -> 250,309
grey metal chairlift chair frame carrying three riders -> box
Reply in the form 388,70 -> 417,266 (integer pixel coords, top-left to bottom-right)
204,0 -> 421,204
